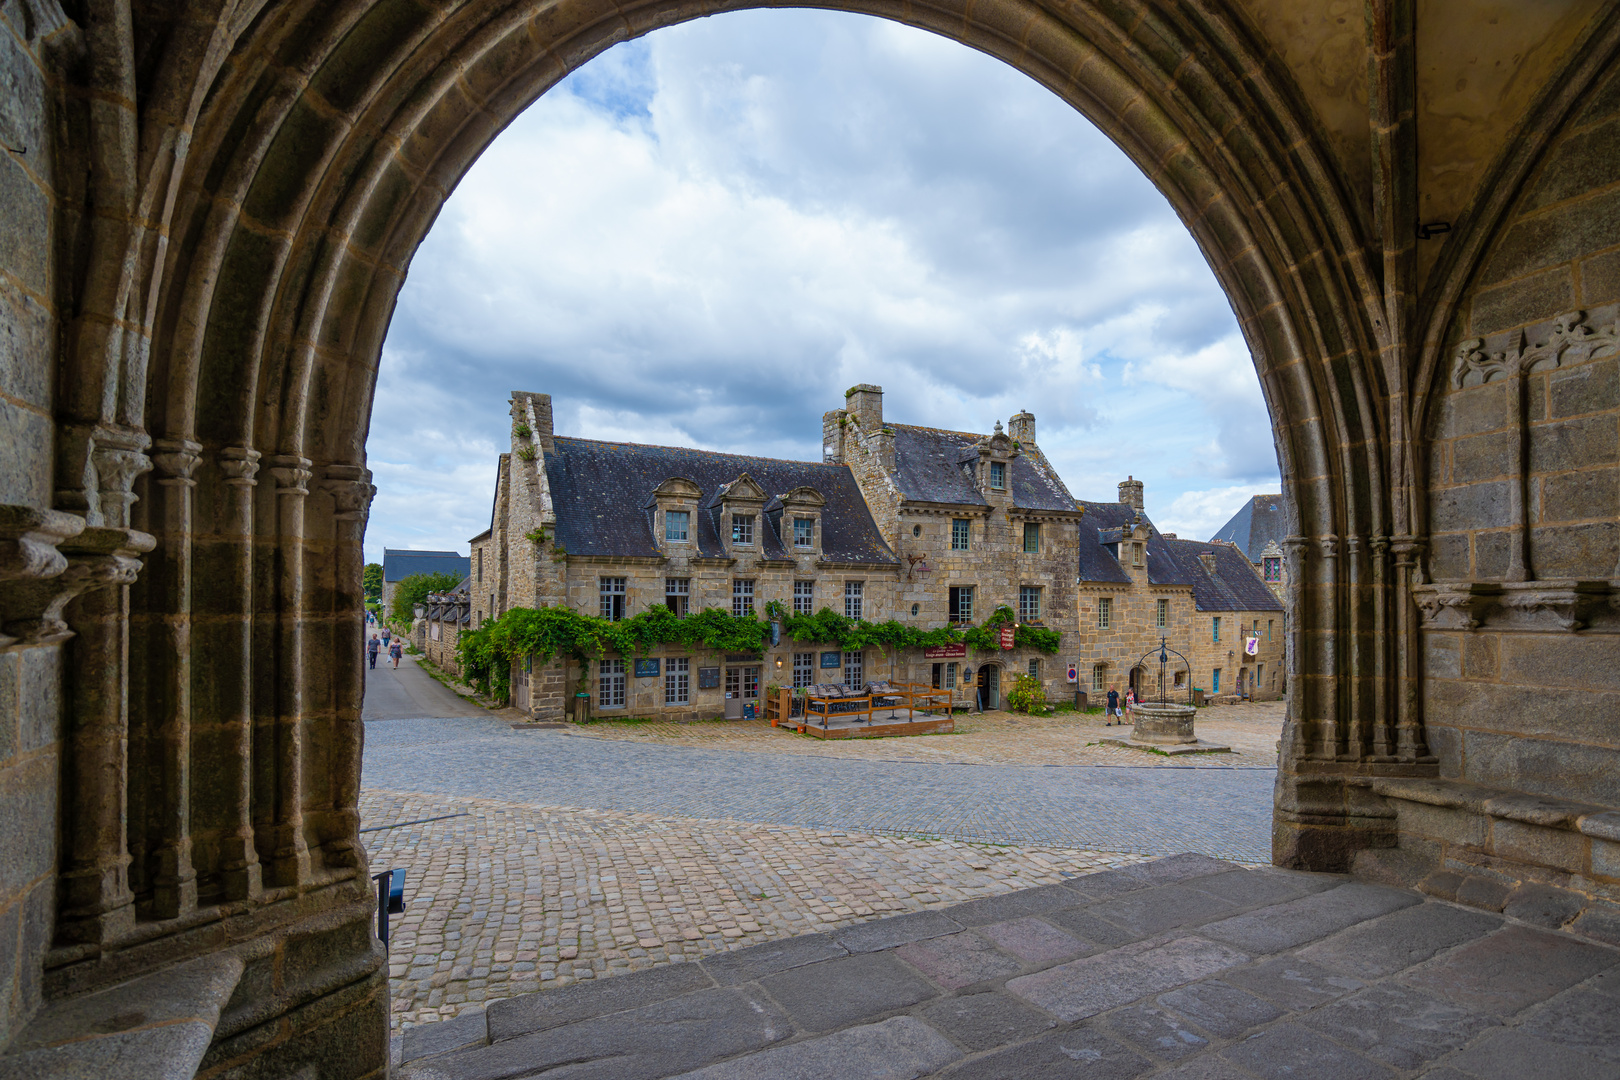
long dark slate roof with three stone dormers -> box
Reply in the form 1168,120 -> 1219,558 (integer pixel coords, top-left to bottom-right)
544,437 -> 899,565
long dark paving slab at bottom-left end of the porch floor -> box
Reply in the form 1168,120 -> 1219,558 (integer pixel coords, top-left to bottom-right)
397,988 -> 792,1080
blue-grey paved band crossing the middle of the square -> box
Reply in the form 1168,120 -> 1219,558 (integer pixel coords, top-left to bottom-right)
365,717 -> 1275,863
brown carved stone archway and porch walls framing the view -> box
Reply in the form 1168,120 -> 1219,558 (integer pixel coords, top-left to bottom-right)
0,0 -> 1620,1080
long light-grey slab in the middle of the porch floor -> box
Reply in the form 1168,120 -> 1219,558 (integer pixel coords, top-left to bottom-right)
1008,938 -> 1249,1023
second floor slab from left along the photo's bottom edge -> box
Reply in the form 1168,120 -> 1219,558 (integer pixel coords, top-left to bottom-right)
676,1017 -> 962,1080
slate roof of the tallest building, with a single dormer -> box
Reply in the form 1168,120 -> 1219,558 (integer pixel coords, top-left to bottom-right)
886,424 -> 1074,510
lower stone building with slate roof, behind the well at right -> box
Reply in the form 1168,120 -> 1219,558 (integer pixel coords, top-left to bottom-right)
1066,478 -> 1286,704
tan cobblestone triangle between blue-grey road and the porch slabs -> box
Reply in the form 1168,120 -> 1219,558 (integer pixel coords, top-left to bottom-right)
360,789 -> 1142,1028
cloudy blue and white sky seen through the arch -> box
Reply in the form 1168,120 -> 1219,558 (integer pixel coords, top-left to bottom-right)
366,10 -> 1280,560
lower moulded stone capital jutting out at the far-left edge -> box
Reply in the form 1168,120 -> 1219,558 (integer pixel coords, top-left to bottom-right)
0,526 -> 157,644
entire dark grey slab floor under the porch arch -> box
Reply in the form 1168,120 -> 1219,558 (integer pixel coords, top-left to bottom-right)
397,855 -> 1620,1080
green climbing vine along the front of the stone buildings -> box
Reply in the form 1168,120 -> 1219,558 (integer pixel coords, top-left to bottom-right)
455,601 -> 1063,699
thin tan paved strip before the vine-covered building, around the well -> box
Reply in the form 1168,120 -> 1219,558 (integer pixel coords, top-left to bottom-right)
563,701 -> 1286,769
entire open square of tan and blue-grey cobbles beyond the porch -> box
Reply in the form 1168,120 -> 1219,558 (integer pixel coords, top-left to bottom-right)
361,659 -> 1280,1027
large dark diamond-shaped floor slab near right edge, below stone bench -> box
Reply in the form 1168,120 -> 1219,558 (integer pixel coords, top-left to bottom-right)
1401,926 -> 1620,1015
